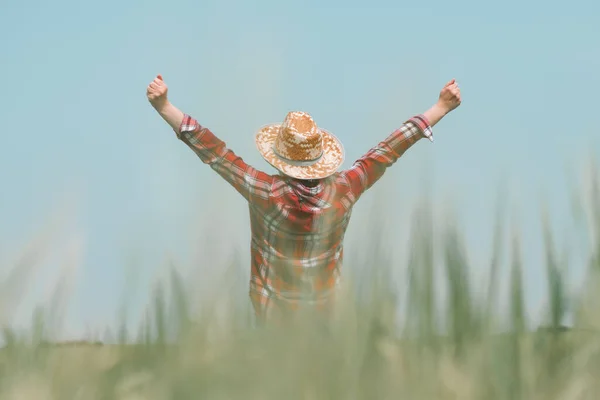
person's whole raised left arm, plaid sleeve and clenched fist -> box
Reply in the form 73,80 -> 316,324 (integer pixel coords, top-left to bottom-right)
146,75 -> 273,204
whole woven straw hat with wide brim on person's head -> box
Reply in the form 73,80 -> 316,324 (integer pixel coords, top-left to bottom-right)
255,111 -> 344,179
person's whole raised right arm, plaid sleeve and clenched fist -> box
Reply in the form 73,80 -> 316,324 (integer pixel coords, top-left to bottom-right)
341,79 -> 461,202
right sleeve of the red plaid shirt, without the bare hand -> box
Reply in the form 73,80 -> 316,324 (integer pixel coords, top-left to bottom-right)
341,115 -> 433,203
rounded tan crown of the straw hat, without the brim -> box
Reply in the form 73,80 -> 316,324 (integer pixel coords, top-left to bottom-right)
274,111 -> 323,162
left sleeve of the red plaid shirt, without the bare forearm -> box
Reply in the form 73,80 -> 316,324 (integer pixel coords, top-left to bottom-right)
175,114 -> 273,203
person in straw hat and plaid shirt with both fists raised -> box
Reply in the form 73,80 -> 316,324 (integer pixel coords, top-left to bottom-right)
146,75 -> 461,323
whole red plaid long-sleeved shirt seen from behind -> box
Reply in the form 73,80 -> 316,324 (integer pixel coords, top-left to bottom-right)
176,115 -> 433,320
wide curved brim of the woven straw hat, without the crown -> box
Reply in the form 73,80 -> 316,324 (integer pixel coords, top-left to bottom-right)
255,124 -> 344,179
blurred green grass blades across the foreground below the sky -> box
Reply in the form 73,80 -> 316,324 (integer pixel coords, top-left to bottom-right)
0,164 -> 600,400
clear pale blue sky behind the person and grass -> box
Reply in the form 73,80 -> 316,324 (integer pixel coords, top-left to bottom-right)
0,0 -> 600,338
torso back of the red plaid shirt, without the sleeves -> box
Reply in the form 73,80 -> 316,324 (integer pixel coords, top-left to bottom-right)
249,173 -> 351,313
